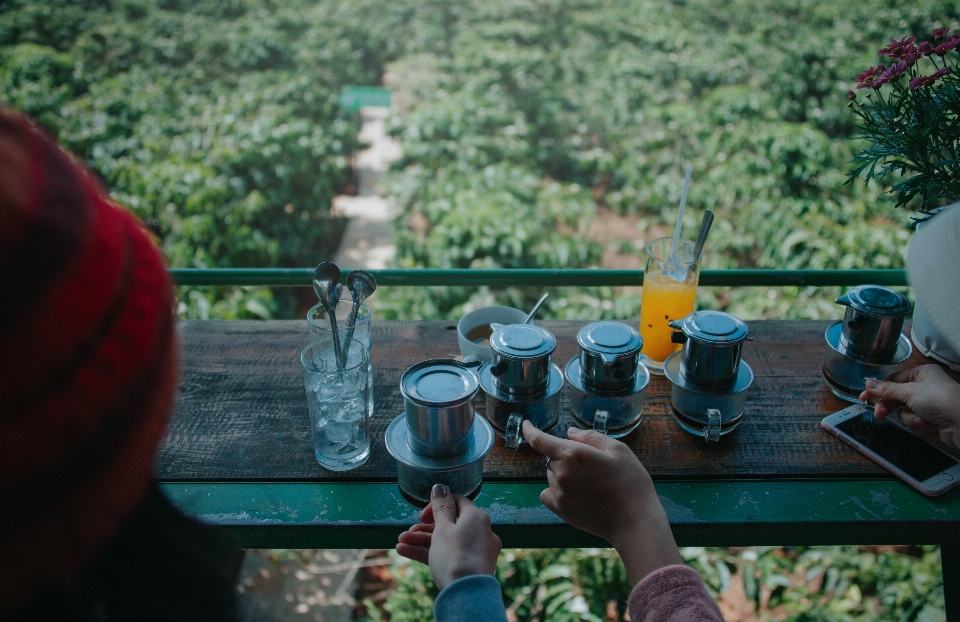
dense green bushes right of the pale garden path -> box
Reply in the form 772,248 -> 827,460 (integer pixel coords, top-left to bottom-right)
385,0 -> 958,319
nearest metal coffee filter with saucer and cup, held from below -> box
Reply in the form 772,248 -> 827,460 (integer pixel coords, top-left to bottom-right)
384,359 -> 494,508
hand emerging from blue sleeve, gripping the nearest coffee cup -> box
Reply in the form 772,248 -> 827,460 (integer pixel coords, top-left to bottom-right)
397,484 -> 502,590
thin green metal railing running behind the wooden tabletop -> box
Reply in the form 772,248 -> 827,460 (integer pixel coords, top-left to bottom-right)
170,268 -> 907,287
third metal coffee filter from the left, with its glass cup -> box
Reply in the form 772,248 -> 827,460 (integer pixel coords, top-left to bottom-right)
564,322 -> 650,438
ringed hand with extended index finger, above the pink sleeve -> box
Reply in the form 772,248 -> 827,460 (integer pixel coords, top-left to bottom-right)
523,421 -> 683,585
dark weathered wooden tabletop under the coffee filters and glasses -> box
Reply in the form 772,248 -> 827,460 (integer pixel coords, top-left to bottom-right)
157,321 -> 886,481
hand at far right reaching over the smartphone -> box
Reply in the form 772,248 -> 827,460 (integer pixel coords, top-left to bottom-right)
860,365 -> 960,447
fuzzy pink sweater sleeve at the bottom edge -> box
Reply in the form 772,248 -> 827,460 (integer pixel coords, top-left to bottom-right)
629,566 -> 723,622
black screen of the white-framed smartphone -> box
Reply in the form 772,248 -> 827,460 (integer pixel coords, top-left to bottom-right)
835,410 -> 957,482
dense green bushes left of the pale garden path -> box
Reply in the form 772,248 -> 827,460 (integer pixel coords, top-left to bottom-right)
0,0 -> 402,317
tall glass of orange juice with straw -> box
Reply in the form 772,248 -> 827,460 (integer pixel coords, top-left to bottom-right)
640,237 -> 700,374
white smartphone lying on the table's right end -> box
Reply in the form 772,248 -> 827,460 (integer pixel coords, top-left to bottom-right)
820,404 -> 960,497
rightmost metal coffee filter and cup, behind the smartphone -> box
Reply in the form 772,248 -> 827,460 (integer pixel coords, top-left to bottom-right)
823,285 -> 913,402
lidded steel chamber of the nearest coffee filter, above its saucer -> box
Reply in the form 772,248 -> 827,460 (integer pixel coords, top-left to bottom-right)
400,359 -> 480,458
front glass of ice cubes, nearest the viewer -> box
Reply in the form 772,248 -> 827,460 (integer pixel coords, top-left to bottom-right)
300,333 -> 373,471
